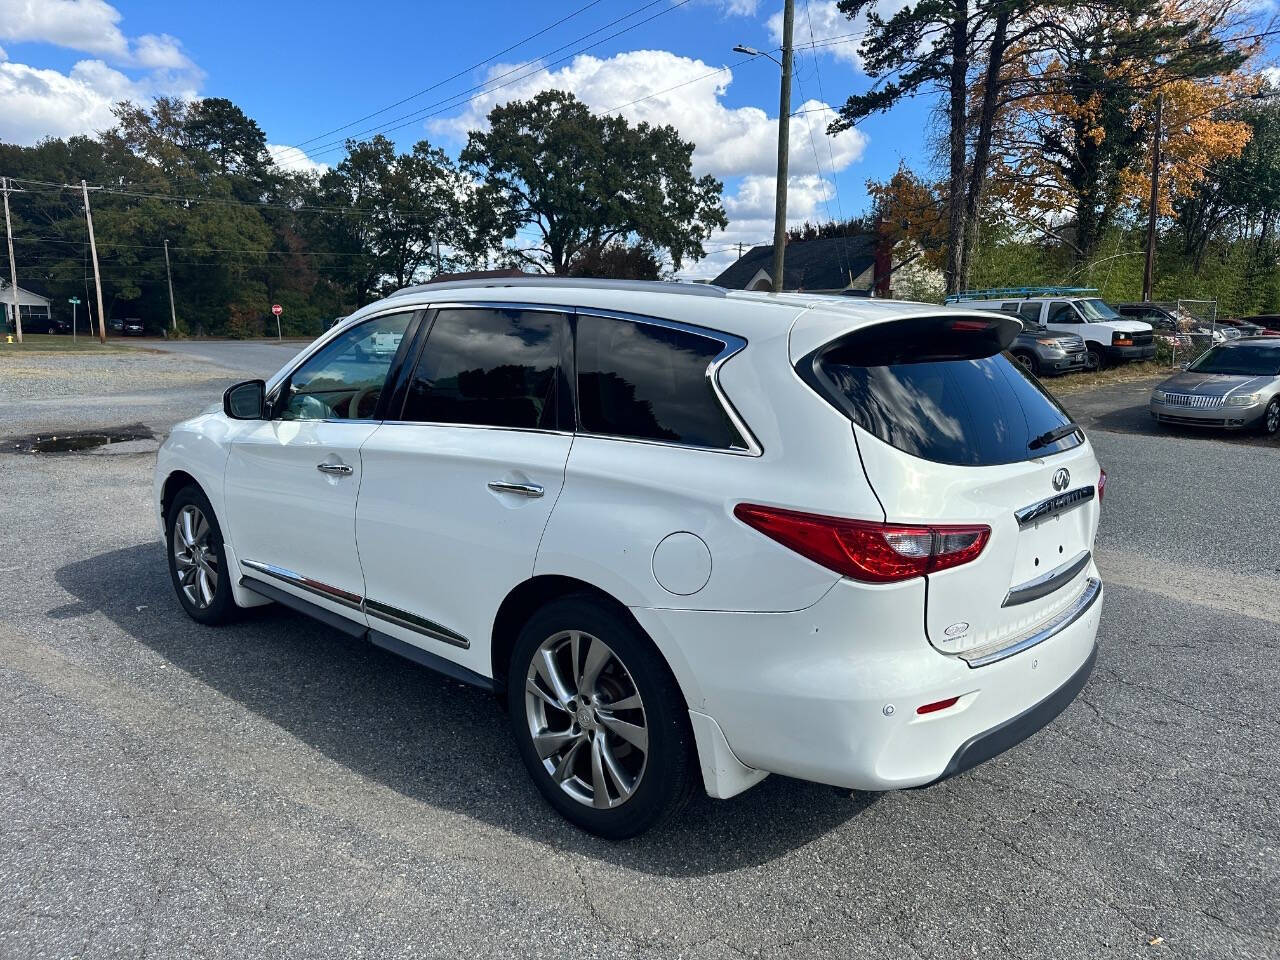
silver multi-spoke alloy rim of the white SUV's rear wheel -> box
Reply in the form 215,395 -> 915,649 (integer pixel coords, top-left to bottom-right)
525,630 -> 649,809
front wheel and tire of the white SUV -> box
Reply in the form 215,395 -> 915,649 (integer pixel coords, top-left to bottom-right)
165,486 -> 238,626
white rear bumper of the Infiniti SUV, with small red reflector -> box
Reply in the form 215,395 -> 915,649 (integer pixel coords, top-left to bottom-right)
632,563 -> 1102,794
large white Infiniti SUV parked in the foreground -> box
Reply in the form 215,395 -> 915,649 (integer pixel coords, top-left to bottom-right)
155,279 -> 1106,838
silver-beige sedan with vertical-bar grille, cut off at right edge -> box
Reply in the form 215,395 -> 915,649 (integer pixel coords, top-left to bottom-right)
1151,337 -> 1280,434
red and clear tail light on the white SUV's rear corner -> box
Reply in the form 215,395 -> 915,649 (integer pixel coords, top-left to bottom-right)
733,503 -> 991,584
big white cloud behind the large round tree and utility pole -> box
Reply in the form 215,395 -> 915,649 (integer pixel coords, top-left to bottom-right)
428,50 -> 867,178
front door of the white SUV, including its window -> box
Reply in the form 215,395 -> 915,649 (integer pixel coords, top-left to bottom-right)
224,312 -> 412,621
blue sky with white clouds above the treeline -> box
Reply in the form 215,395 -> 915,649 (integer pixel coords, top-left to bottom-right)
0,0 -> 931,276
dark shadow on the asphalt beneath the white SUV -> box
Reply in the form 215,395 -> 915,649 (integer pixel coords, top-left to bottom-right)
55,544 -> 877,876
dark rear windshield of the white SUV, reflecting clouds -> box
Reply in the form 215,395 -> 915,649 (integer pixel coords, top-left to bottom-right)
814,319 -> 1082,466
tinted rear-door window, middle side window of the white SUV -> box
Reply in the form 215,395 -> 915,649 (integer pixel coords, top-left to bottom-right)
401,307 -> 571,430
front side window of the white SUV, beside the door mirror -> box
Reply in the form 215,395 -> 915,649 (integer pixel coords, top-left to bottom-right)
279,314 -> 413,420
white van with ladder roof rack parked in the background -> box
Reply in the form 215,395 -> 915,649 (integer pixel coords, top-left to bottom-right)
947,291 -> 1156,370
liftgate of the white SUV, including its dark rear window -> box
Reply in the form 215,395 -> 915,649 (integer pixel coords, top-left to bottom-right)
798,319 -> 1098,653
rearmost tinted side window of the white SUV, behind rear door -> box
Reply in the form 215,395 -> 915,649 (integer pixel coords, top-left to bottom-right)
576,316 -> 746,449
